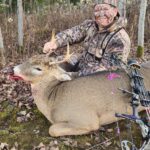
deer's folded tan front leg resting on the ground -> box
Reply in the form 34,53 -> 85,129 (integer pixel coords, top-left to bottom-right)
49,122 -> 99,137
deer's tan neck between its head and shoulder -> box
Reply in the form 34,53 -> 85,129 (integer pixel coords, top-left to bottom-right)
31,79 -> 59,122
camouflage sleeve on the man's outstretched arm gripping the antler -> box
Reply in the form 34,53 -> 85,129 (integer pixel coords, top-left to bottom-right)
56,20 -> 93,47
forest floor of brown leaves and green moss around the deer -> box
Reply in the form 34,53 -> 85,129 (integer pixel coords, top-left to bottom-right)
0,46 -> 150,150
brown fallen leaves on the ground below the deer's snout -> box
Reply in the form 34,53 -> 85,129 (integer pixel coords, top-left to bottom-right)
0,66 -> 35,122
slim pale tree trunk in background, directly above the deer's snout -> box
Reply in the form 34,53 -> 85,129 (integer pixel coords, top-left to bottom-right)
17,0 -> 24,47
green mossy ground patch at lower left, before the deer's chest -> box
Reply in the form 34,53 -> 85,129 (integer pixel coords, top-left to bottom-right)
0,103 -> 49,150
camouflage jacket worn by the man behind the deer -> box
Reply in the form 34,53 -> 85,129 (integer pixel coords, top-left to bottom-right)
56,18 -> 130,74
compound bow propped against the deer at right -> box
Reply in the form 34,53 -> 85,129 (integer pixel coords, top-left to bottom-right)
105,54 -> 150,150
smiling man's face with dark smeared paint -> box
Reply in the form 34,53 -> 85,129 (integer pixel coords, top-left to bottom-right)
94,4 -> 118,27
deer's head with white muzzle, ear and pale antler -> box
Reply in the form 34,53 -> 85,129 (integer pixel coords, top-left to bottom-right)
14,52 -> 72,84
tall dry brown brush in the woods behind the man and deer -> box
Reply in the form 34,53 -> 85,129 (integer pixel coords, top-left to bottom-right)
0,0 -> 150,66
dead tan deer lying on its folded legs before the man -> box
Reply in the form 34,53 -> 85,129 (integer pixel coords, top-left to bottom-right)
14,51 -> 150,137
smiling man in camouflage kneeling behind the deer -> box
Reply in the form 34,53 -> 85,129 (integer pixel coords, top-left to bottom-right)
43,2 -> 131,76
